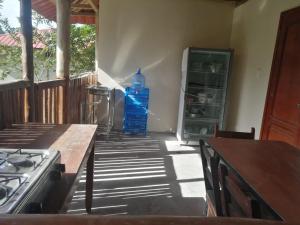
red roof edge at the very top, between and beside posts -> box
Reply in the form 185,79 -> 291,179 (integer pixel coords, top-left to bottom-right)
31,0 -> 96,24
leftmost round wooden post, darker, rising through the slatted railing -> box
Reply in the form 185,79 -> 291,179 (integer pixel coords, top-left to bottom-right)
20,0 -> 35,122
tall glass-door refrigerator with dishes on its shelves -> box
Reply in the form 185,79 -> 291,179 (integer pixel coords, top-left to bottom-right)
177,48 -> 232,143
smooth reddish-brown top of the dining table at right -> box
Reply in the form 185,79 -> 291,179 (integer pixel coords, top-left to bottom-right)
208,138 -> 300,224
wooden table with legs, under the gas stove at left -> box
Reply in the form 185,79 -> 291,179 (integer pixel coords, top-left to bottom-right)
0,123 -> 97,213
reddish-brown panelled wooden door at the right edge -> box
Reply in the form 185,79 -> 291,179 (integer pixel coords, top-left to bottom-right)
261,7 -> 300,147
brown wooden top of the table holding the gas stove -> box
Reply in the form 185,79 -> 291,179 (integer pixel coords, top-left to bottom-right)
0,123 -> 97,174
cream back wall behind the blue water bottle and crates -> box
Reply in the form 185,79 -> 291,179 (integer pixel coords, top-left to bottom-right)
97,0 -> 234,131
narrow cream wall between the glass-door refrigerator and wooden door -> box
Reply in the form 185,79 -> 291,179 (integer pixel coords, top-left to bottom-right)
227,0 -> 300,138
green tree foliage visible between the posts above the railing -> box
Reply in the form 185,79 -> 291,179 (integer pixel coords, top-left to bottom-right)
0,9 -> 96,80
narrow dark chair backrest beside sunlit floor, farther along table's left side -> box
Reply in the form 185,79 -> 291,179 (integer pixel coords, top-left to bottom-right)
200,140 -> 222,216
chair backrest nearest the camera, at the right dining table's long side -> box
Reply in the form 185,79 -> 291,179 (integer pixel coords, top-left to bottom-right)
218,163 -> 261,218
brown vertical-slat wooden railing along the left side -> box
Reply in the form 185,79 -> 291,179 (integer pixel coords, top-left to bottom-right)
0,74 -> 97,129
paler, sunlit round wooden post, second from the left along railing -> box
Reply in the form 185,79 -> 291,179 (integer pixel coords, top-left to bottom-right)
56,0 -> 71,123
